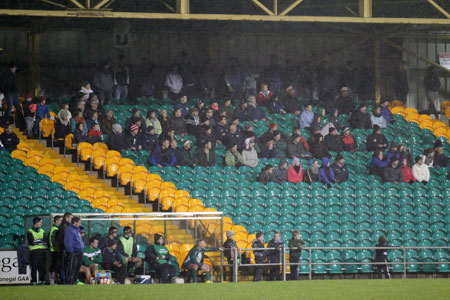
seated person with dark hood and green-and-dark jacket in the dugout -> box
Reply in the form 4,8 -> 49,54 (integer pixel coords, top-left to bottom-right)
145,233 -> 177,283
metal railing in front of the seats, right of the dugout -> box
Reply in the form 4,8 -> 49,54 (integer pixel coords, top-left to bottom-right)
222,246 -> 450,282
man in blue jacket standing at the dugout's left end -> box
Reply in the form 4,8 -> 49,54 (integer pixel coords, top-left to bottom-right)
64,216 -> 84,284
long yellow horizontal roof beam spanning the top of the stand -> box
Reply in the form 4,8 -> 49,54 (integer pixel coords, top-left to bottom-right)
0,9 -> 450,25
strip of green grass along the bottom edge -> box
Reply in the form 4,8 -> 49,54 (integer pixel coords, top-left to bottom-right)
0,279 -> 450,300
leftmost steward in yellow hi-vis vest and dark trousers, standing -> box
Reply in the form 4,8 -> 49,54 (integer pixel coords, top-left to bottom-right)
27,217 -> 47,285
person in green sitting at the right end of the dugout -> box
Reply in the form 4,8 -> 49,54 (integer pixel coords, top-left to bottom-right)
183,240 -> 223,283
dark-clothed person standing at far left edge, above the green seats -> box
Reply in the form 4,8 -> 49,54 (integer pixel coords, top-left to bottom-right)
0,62 -> 25,130
